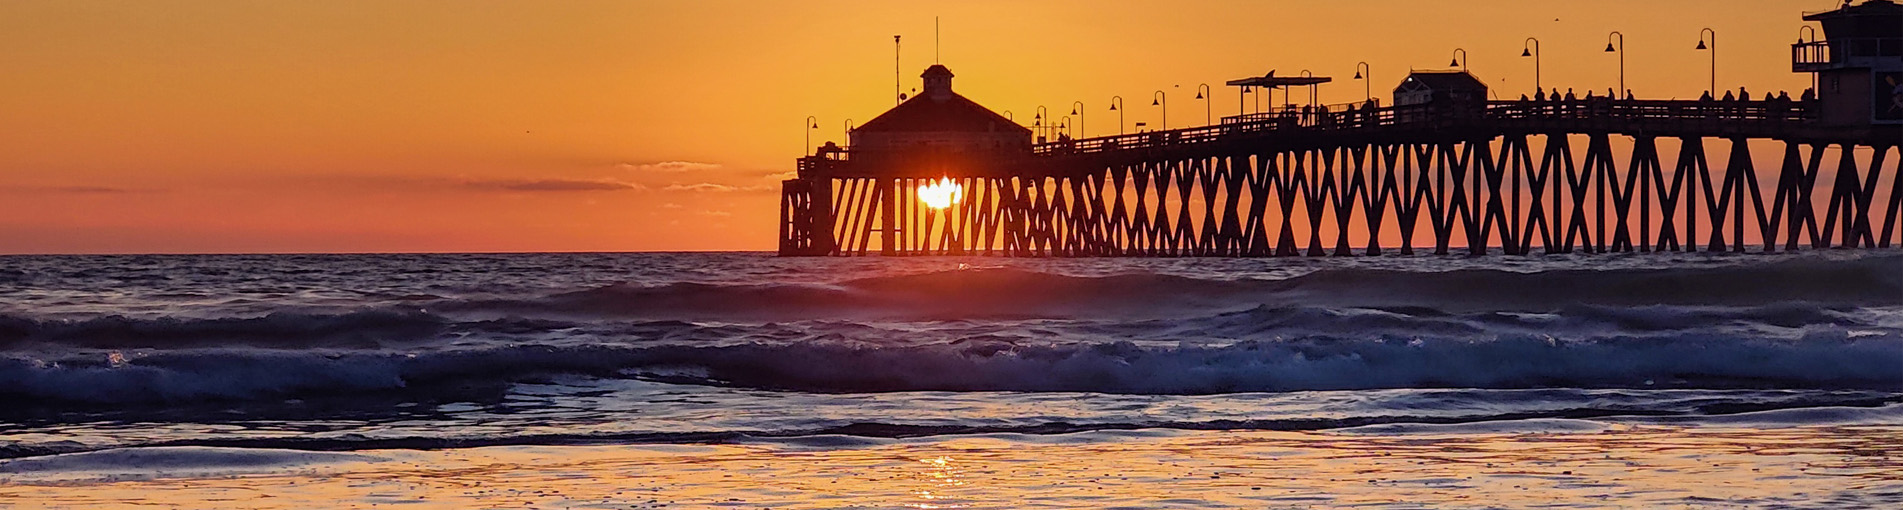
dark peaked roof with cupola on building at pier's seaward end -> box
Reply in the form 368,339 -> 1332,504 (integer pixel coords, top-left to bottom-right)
853,65 -> 1031,137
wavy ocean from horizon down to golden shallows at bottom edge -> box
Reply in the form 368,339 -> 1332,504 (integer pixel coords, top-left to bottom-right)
0,251 -> 1903,508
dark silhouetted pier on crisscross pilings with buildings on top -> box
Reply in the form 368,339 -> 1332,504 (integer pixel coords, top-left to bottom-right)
780,0 -> 1903,257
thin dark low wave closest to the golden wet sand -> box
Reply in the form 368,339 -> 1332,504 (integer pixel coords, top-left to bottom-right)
11,398 -> 1903,462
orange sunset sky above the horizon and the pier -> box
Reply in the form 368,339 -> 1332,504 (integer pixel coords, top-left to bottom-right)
0,0 -> 1836,253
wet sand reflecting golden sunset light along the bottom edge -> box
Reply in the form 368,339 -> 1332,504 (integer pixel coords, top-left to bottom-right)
0,421 -> 1903,508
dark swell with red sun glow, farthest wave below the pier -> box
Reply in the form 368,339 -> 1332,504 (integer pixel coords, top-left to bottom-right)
434,255 -> 1903,320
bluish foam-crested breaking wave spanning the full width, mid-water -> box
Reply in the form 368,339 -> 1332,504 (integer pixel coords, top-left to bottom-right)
0,327 -> 1903,405
